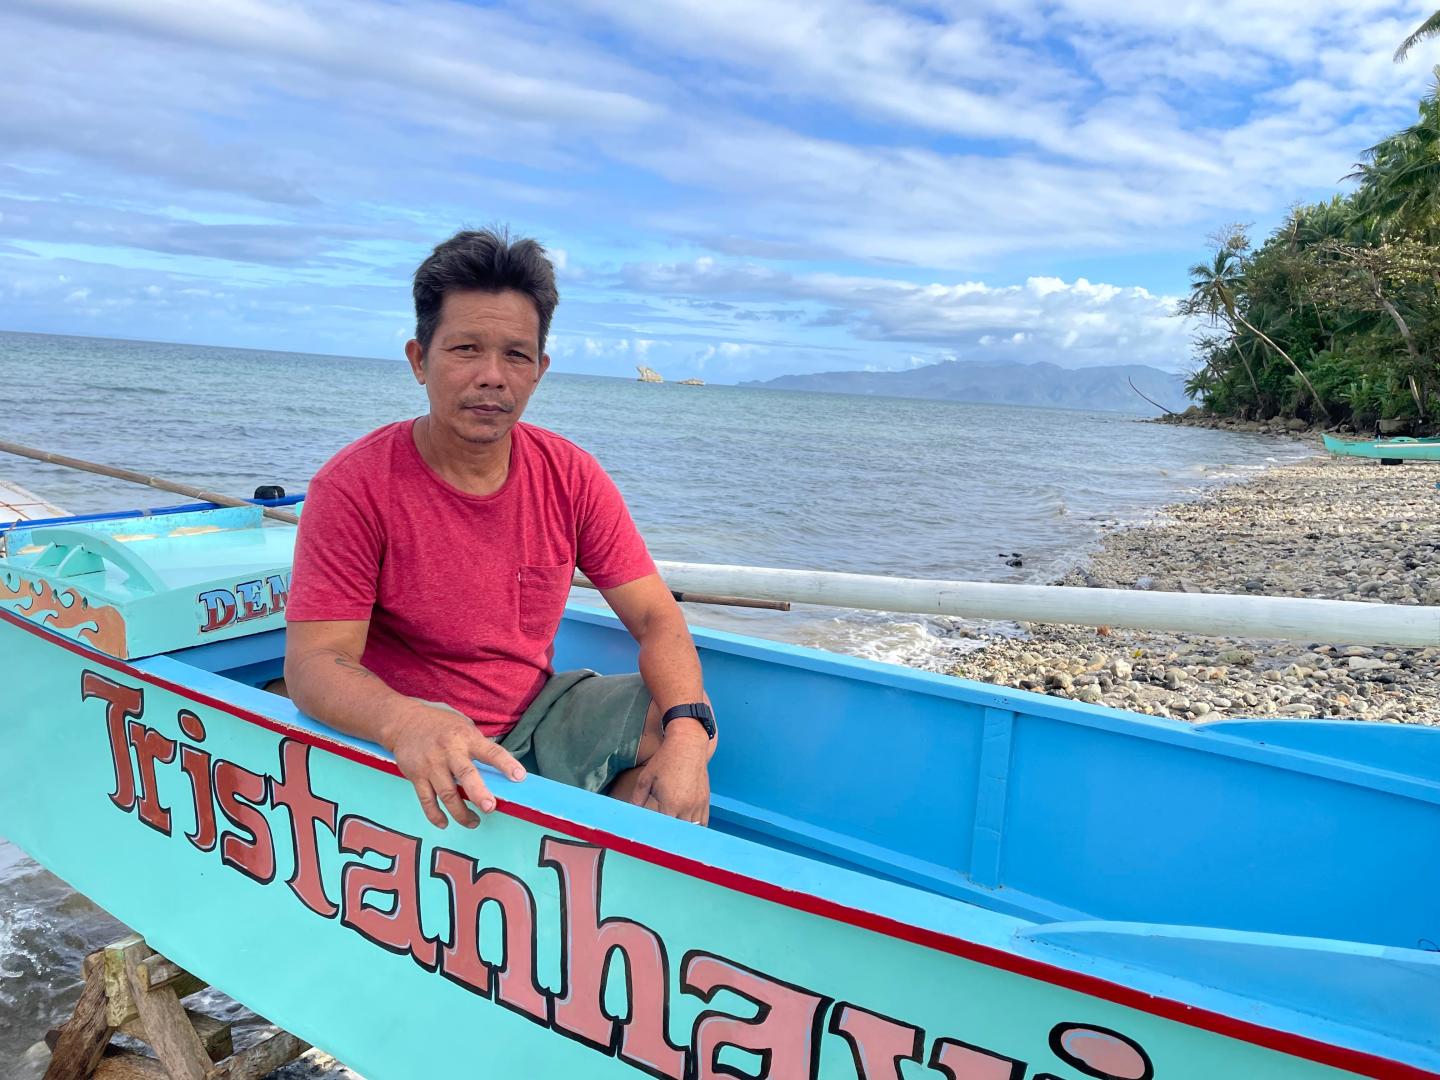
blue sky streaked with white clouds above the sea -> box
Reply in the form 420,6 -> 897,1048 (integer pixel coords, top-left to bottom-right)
0,0 -> 1440,383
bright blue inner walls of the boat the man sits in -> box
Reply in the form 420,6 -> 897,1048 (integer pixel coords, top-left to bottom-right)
170,606 -> 1440,950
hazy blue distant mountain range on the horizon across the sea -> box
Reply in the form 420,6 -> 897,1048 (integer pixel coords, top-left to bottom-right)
740,360 -> 1191,416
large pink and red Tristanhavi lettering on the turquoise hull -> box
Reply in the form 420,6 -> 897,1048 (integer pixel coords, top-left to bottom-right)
81,671 -> 1155,1080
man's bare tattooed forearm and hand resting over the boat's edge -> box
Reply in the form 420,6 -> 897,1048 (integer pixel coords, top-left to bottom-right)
285,621 -> 526,828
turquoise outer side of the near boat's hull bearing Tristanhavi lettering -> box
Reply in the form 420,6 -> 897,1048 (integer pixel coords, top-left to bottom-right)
0,615 -> 1434,1080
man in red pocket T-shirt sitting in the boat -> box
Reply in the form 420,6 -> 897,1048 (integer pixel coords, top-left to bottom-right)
285,230 -> 714,828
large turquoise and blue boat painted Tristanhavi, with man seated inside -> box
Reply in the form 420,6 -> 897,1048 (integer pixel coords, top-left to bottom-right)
0,507 -> 1440,1080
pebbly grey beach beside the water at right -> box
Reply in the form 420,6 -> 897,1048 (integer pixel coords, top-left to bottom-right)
949,455 -> 1440,726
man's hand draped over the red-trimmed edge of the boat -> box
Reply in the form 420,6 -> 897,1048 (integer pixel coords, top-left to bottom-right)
380,701 -> 526,829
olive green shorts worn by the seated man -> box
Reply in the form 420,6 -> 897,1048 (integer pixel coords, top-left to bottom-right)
417,668 -> 649,792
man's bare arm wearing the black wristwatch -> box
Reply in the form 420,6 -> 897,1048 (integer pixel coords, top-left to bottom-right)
600,575 -> 716,822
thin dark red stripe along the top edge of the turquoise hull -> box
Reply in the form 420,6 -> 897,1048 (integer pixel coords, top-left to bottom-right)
0,609 -> 1440,1080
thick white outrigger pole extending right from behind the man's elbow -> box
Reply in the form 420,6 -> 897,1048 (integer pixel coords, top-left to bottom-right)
658,563 -> 1440,648
